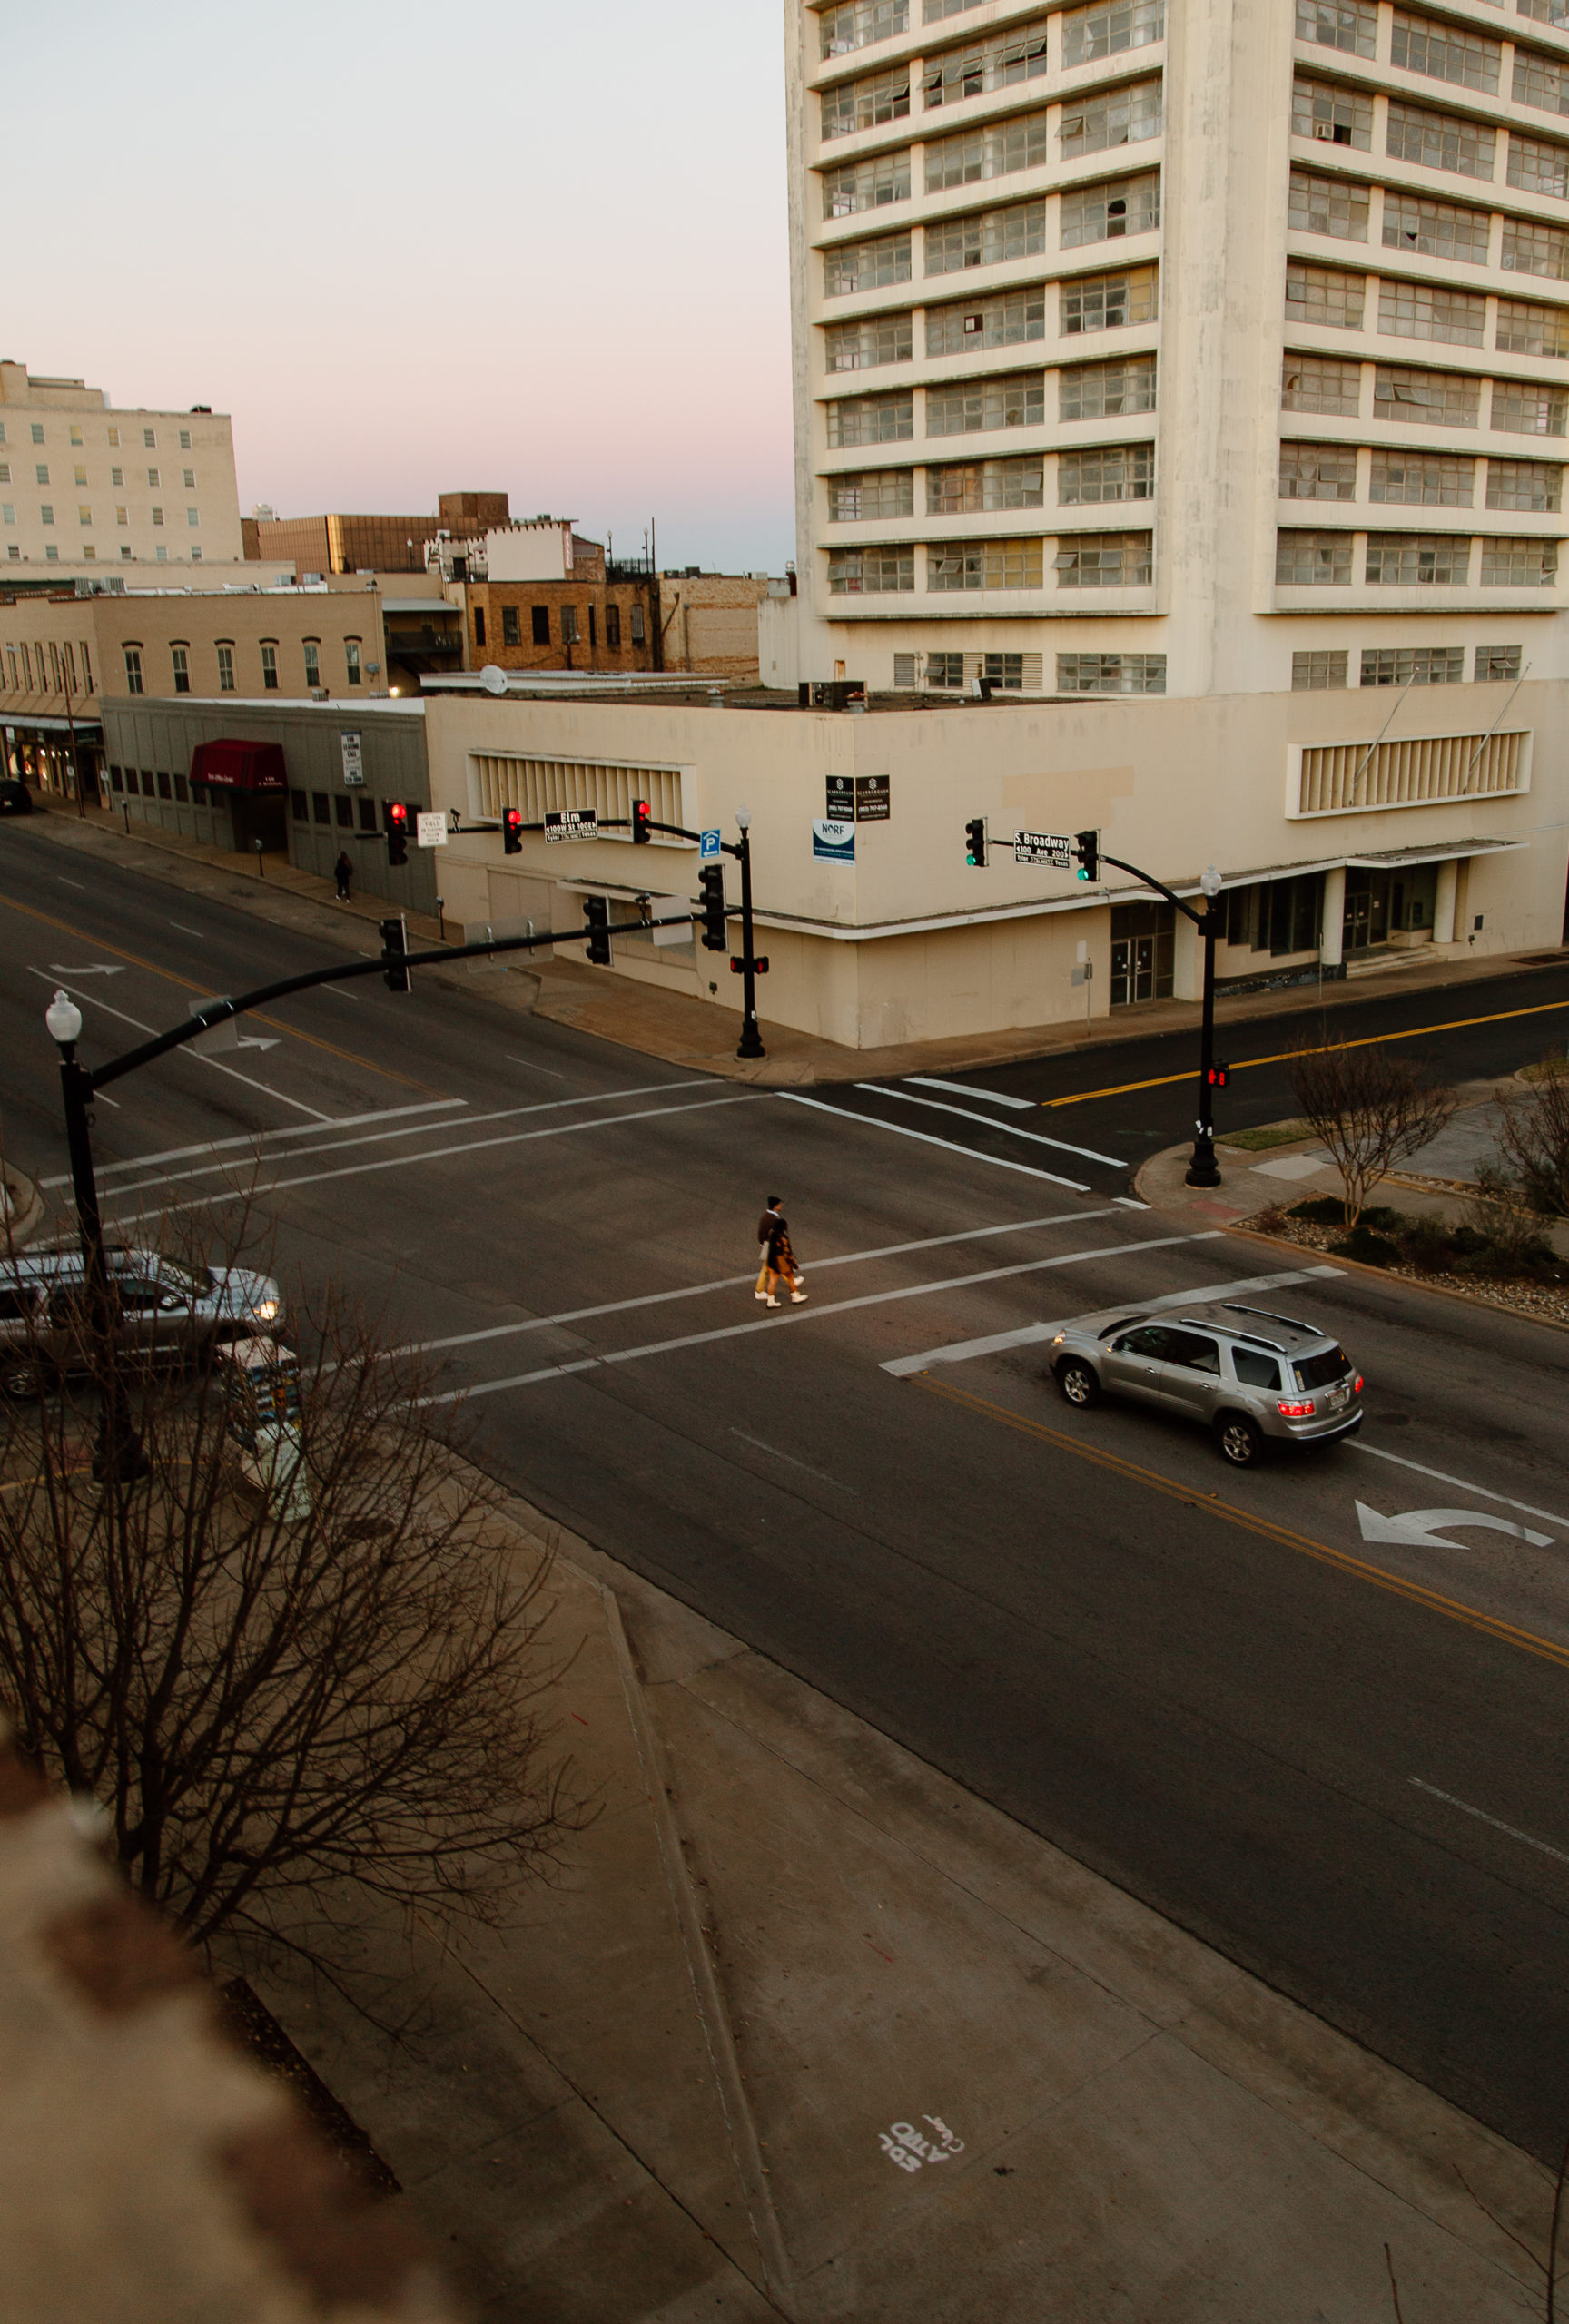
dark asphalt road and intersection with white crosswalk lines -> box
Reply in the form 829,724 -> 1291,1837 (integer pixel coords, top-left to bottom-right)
0,825 -> 1569,2159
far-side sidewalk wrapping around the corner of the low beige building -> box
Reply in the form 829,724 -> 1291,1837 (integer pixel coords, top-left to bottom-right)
18,811 -> 1569,1088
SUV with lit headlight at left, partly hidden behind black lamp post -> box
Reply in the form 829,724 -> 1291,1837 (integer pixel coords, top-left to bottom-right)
0,1250 -> 283,1397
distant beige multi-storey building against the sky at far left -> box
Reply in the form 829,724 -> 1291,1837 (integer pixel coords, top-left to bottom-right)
0,362 -> 244,586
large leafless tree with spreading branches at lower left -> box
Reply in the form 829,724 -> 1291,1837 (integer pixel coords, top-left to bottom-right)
0,1198 -> 586,1983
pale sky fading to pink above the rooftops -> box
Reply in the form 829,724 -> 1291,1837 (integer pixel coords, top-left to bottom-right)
0,0 -> 795,572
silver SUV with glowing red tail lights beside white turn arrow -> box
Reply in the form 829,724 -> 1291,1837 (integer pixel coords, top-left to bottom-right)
1051,1299 -> 1362,1469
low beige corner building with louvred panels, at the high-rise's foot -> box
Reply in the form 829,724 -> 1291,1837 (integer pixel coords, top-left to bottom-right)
409,681 -> 1569,1049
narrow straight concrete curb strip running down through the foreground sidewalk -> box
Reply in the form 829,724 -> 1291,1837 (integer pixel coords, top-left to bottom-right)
599,1569 -> 793,2317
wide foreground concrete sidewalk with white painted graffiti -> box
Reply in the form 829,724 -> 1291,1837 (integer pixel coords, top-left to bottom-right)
270,1503 -> 1551,2324
